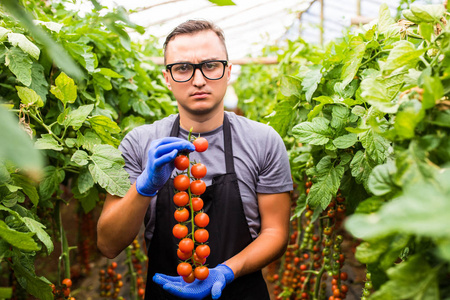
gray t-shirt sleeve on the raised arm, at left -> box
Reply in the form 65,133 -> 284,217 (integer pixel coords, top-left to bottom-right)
119,130 -> 143,184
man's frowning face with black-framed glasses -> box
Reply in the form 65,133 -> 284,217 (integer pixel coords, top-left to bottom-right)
163,30 -> 231,115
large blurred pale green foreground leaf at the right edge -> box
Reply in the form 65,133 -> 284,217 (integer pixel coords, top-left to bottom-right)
346,170 -> 450,239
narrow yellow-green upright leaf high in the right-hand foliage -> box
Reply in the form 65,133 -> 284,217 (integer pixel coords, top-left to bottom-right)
341,36 -> 366,89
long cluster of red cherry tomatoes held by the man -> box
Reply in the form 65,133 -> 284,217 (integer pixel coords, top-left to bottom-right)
172,137 -> 211,283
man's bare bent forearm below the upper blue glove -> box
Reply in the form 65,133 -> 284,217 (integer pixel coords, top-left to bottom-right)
97,184 -> 151,258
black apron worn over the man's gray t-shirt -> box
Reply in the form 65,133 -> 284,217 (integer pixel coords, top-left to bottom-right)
145,114 -> 270,300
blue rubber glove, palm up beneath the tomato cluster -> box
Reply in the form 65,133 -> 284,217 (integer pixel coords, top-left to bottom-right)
153,264 -> 234,300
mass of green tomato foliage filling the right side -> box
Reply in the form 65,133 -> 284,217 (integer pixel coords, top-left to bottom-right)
236,5 -> 450,299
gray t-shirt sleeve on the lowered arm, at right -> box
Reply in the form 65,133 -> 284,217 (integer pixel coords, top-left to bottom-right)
256,127 -> 293,194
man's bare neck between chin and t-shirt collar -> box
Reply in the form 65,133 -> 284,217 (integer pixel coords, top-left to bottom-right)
180,109 -> 224,133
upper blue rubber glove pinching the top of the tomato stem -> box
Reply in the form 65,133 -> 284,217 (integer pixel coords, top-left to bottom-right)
136,137 -> 195,197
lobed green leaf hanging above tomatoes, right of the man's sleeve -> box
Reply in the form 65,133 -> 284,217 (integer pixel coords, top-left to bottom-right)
306,156 -> 345,209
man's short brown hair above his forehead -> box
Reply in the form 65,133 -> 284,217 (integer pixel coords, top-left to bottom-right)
163,20 -> 228,63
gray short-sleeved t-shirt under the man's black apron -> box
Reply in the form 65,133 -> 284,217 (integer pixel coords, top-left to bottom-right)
119,112 -> 293,240
